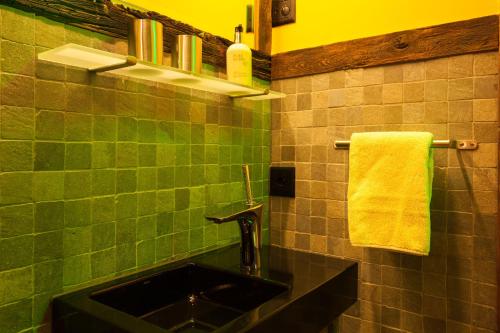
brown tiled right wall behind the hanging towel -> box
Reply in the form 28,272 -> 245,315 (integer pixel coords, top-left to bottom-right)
270,52 -> 498,333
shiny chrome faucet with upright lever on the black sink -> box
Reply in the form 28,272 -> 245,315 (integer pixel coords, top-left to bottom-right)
206,164 -> 264,272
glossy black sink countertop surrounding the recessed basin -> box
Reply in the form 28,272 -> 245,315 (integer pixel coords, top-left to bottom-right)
53,245 -> 358,333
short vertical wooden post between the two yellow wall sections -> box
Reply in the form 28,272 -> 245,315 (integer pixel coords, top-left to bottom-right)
254,0 -> 273,54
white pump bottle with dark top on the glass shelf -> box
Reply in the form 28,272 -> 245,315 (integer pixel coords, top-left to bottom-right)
226,24 -> 252,87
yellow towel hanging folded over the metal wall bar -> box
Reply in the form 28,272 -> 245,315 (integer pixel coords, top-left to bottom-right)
348,132 -> 434,255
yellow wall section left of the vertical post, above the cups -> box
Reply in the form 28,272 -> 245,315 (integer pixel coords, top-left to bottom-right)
113,0 -> 254,47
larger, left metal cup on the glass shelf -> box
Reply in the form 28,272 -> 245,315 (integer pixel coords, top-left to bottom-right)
128,19 -> 163,65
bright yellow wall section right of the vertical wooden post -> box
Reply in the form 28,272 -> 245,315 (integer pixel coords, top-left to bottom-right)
273,0 -> 500,54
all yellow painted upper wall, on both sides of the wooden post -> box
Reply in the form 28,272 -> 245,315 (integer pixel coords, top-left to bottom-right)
114,0 -> 500,54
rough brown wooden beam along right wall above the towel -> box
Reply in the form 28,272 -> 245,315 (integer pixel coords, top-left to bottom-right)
271,15 -> 499,80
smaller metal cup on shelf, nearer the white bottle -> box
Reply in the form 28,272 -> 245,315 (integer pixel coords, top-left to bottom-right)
172,35 -> 203,73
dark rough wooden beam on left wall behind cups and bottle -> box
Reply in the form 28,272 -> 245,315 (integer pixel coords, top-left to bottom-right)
2,0 -> 271,81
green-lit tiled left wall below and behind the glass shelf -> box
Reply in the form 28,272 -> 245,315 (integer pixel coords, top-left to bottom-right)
0,6 -> 270,333
